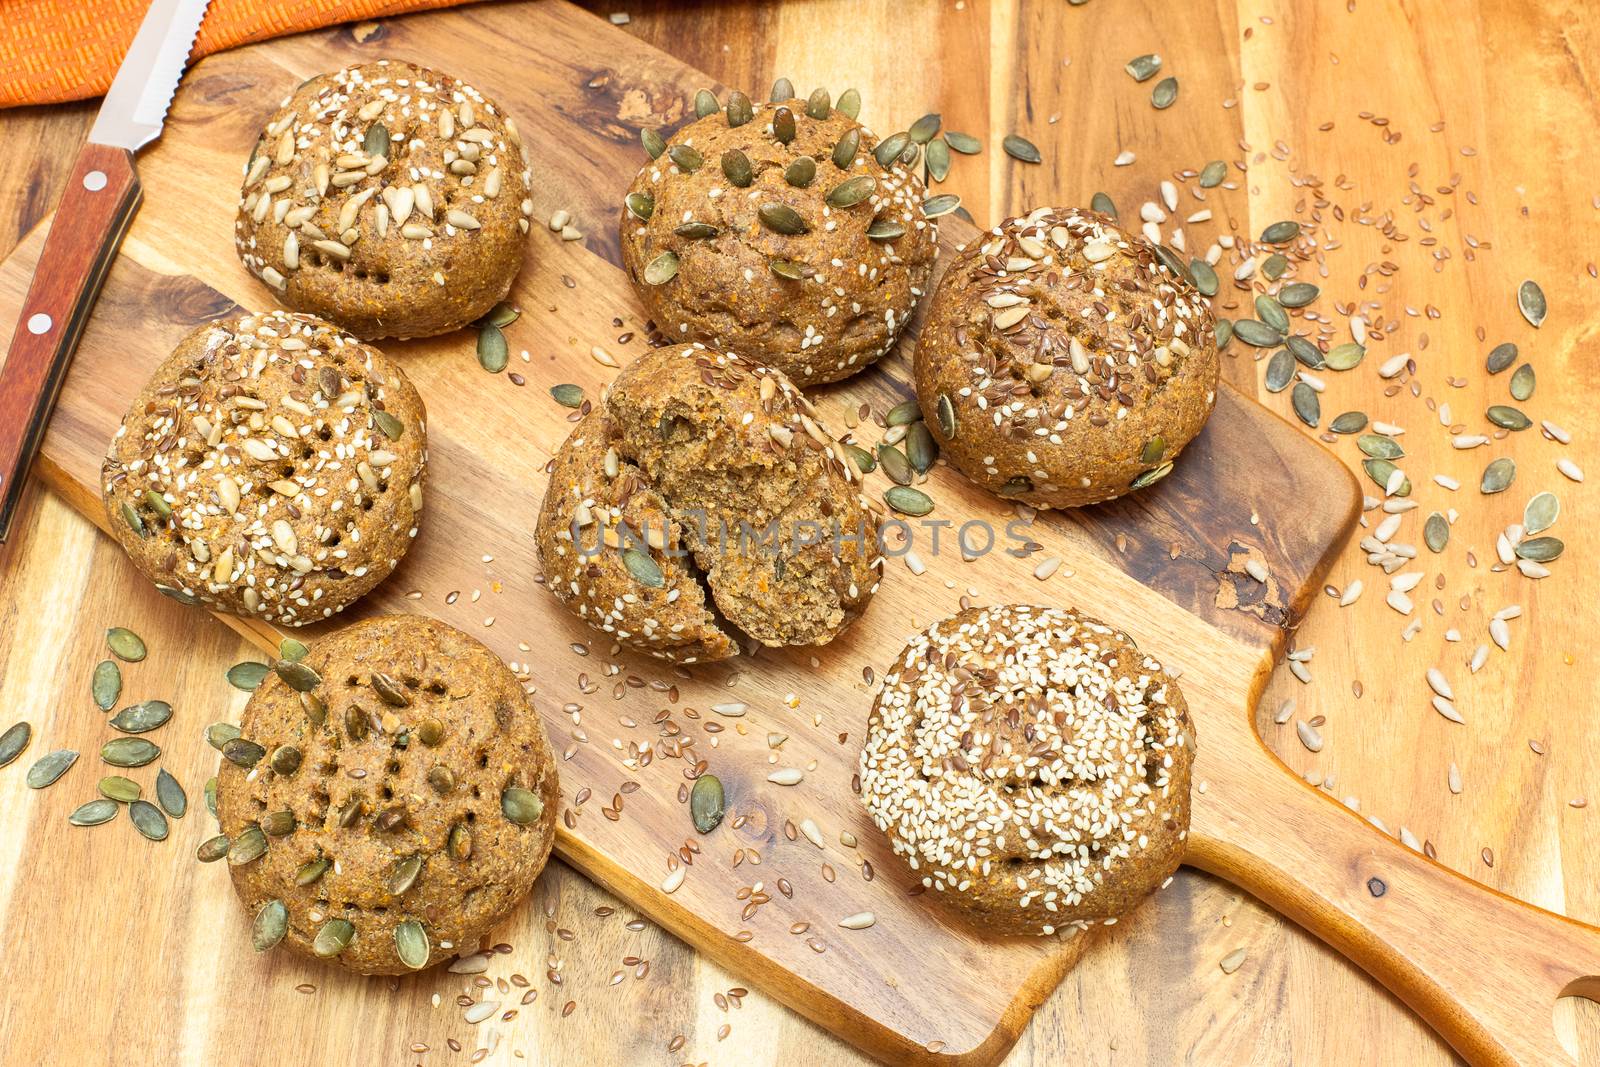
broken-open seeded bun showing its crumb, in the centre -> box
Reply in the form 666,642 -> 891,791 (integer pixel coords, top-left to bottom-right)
538,344 -> 883,662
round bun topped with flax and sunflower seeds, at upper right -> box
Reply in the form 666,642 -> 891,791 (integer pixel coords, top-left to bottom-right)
915,208 -> 1218,507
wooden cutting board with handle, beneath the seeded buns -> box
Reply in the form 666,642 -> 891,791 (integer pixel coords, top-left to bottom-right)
0,3 -> 1600,1064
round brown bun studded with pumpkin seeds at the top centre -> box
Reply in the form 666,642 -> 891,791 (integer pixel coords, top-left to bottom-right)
621,90 -> 938,387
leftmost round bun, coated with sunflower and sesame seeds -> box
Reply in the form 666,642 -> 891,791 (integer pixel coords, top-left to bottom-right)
101,312 -> 427,625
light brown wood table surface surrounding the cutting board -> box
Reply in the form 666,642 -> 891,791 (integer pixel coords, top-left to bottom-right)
0,0 -> 1595,1062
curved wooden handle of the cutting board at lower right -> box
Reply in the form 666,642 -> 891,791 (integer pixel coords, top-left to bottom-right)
1187,718 -> 1600,1064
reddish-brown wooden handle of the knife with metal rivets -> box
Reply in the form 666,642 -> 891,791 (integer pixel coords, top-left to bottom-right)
0,144 -> 142,541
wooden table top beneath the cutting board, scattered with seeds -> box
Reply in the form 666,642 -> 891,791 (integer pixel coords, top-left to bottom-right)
0,0 -> 1600,1064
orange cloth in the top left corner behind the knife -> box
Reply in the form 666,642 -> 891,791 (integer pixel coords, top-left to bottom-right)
0,0 -> 469,107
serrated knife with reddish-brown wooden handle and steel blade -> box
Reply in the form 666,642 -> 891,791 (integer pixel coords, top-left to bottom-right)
0,0 -> 210,542
